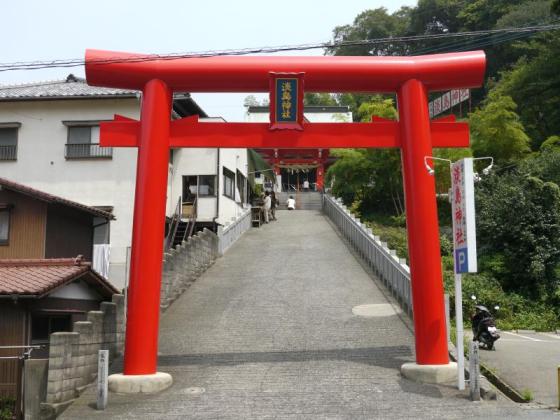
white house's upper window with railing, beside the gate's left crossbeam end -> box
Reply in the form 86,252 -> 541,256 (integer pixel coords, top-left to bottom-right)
63,121 -> 113,159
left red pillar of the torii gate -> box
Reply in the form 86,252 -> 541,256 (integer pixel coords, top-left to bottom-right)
124,80 -> 171,375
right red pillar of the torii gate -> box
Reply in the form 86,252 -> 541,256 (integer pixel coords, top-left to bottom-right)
398,80 -> 449,365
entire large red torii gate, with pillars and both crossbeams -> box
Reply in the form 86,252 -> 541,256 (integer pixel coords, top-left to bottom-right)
86,50 -> 486,390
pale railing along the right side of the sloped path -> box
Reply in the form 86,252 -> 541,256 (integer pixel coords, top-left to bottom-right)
323,194 -> 412,317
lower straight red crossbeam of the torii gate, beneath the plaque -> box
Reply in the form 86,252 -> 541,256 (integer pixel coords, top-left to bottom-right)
100,117 -> 469,149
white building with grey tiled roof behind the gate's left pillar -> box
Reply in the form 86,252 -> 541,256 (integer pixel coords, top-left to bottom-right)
0,75 -> 247,287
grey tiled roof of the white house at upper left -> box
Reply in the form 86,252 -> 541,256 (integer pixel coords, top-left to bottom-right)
0,74 -> 138,101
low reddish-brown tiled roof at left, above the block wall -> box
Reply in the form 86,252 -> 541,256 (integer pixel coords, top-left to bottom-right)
0,256 -> 118,297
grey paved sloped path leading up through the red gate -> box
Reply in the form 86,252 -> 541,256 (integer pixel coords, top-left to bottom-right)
63,211 -> 552,419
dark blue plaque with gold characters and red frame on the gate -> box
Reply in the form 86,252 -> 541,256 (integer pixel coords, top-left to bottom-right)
270,73 -> 303,130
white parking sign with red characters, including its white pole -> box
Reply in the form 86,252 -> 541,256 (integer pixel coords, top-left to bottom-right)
450,158 -> 477,390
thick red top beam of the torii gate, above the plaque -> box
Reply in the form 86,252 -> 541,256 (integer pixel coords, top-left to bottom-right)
86,50 -> 486,93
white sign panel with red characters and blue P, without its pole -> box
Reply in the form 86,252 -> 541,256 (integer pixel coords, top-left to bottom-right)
451,158 -> 477,273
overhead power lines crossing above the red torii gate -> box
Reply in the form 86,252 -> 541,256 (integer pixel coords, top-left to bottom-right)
0,23 -> 560,72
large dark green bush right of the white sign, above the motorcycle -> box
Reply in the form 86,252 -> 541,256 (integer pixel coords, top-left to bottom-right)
476,172 -> 560,299
